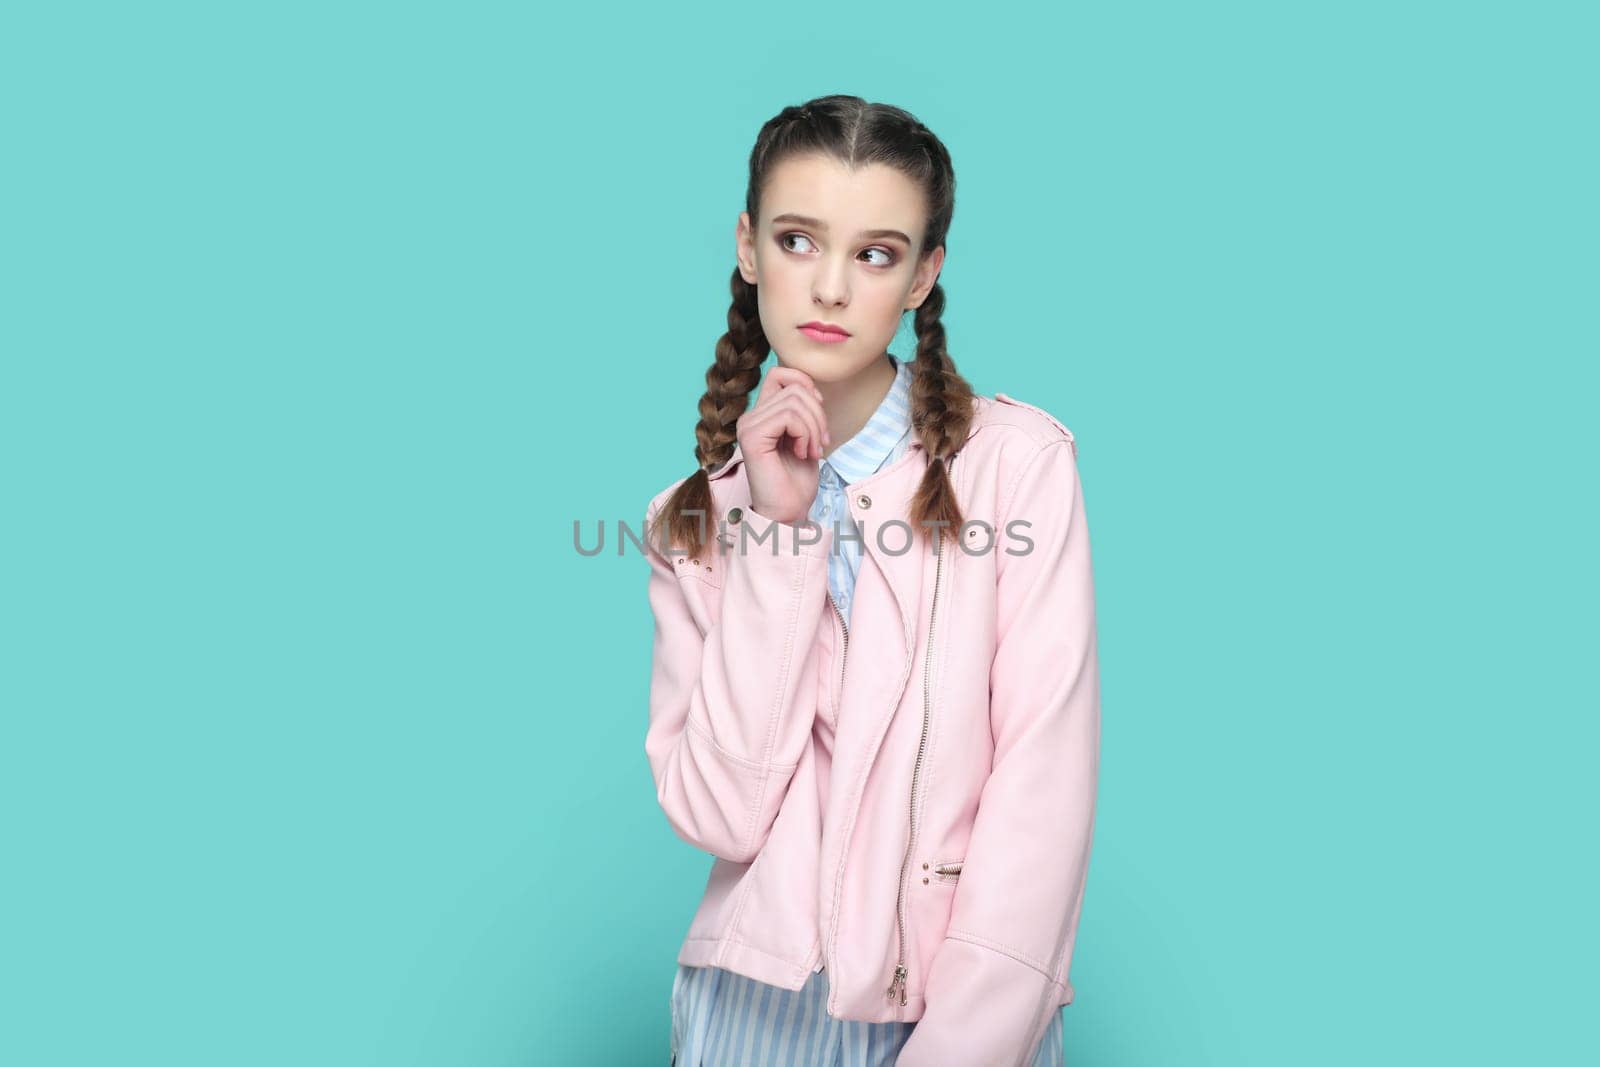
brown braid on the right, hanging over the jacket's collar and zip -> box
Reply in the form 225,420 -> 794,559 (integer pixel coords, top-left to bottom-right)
910,282 -> 973,545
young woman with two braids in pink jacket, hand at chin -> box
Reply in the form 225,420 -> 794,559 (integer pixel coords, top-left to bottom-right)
645,96 -> 1099,1067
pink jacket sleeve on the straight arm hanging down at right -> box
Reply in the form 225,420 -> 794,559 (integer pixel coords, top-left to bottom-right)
898,435 -> 1099,1067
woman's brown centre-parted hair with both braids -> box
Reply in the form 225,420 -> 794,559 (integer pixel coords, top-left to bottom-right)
646,94 -> 973,555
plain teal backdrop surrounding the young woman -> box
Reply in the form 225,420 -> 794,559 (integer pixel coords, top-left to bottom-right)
0,2 -> 1600,1067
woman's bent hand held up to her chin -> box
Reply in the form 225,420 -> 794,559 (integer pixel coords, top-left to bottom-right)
736,366 -> 830,525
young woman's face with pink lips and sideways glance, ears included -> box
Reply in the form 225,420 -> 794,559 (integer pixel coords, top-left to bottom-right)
736,155 -> 944,386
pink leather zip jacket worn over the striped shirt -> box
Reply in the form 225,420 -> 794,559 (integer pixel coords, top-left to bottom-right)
645,394 -> 1099,1067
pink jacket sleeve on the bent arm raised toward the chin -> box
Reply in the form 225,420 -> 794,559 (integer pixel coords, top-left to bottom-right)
645,502 -> 832,862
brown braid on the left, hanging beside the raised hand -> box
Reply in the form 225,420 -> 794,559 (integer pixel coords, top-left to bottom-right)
646,267 -> 771,557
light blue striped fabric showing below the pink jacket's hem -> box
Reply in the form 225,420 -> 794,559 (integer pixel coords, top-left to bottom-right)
670,963 -> 1066,1067
